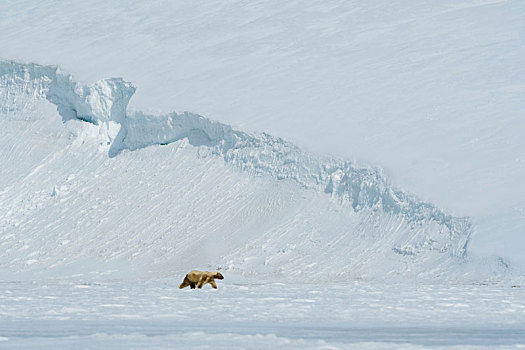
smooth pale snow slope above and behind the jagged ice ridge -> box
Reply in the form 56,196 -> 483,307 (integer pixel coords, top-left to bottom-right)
0,0 -> 525,266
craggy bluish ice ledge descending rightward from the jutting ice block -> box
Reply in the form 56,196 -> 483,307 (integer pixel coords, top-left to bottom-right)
123,112 -> 471,257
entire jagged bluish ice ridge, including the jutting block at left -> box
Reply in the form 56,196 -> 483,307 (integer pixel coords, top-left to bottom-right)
0,62 -> 472,258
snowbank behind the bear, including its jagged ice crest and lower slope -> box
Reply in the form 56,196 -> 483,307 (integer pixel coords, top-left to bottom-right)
0,62 -> 472,279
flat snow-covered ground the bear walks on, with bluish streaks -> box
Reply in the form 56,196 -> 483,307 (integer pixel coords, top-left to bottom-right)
0,276 -> 525,349
